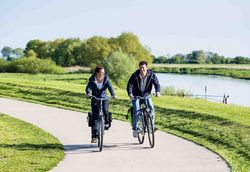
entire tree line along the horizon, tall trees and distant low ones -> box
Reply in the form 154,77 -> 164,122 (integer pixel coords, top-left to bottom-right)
1,32 -> 250,67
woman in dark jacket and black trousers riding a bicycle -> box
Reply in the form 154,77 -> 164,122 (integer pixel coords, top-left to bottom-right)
86,66 -> 116,143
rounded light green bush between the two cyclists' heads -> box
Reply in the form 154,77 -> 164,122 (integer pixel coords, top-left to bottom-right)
104,51 -> 137,88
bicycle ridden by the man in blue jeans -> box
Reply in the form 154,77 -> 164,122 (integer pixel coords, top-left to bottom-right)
135,95 -> 155,148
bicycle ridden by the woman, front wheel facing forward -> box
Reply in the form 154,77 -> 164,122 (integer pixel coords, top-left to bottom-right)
90,95 -> 108,152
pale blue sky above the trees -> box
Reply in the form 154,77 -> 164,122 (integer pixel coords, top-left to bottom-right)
0,0 -> 250,57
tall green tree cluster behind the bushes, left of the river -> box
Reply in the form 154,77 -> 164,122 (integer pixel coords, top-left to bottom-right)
2,32 -> 152,67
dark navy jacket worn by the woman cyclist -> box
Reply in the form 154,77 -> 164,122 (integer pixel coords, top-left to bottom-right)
86,74 -> 115,98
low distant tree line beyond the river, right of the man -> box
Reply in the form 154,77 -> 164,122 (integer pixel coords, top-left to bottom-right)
153,50 -> 250,64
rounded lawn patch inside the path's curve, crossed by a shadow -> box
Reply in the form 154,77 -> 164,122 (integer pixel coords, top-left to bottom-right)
0,114 -> 64,172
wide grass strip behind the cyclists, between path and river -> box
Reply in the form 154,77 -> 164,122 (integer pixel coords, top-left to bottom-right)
0,74 -> 250,172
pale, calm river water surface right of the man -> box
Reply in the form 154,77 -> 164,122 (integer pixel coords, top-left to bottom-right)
156,73 -> 250,106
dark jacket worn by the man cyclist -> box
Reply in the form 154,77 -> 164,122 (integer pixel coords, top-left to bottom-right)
127,69 -> 160,97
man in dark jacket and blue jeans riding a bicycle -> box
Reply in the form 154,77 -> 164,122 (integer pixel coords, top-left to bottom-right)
127,61 -> 160,137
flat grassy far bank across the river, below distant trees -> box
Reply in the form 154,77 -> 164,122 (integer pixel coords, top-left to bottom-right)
152,64 -> 250,79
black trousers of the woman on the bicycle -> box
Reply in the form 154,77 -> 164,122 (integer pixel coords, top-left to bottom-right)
91,99 -> 111,137
